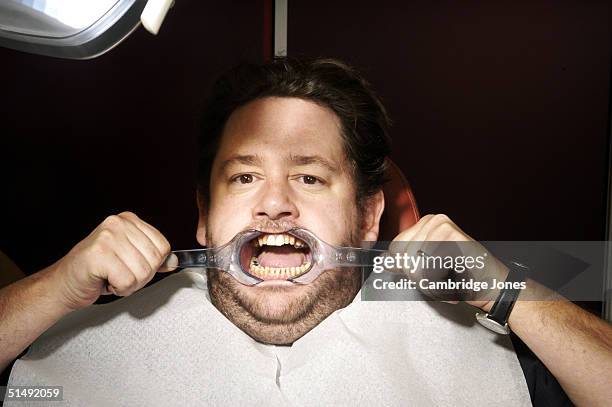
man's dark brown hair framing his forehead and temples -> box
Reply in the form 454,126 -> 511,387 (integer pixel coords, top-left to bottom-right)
198,58 -> 390,208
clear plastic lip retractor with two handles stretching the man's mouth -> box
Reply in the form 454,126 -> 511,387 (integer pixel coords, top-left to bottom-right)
172,228 -> 384,285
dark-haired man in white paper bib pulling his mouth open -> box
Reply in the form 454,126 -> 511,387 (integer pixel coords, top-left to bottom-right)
0,59 -> 612,405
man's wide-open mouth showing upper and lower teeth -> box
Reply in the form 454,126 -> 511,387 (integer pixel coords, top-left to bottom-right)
240,233 -> 312,280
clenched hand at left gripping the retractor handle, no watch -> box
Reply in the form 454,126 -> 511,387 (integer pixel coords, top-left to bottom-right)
50,212 -> 177,310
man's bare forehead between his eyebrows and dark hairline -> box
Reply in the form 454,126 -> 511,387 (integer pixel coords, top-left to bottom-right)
215,97 -> 345,164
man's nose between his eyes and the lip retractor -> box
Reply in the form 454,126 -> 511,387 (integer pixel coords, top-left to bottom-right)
253,179 -> 299,220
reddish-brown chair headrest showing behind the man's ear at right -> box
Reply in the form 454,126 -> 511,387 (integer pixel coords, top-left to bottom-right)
378,159 -> 420,241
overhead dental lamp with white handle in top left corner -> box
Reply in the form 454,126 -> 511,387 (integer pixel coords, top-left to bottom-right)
0,0 -> 174,59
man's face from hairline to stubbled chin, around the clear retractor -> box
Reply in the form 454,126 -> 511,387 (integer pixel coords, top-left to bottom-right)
198,97 -> 378,344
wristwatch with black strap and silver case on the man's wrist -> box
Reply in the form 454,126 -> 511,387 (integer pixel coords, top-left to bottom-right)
476,261 -> 529,335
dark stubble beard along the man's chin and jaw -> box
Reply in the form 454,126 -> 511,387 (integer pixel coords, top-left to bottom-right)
207,222 -> 361,345
